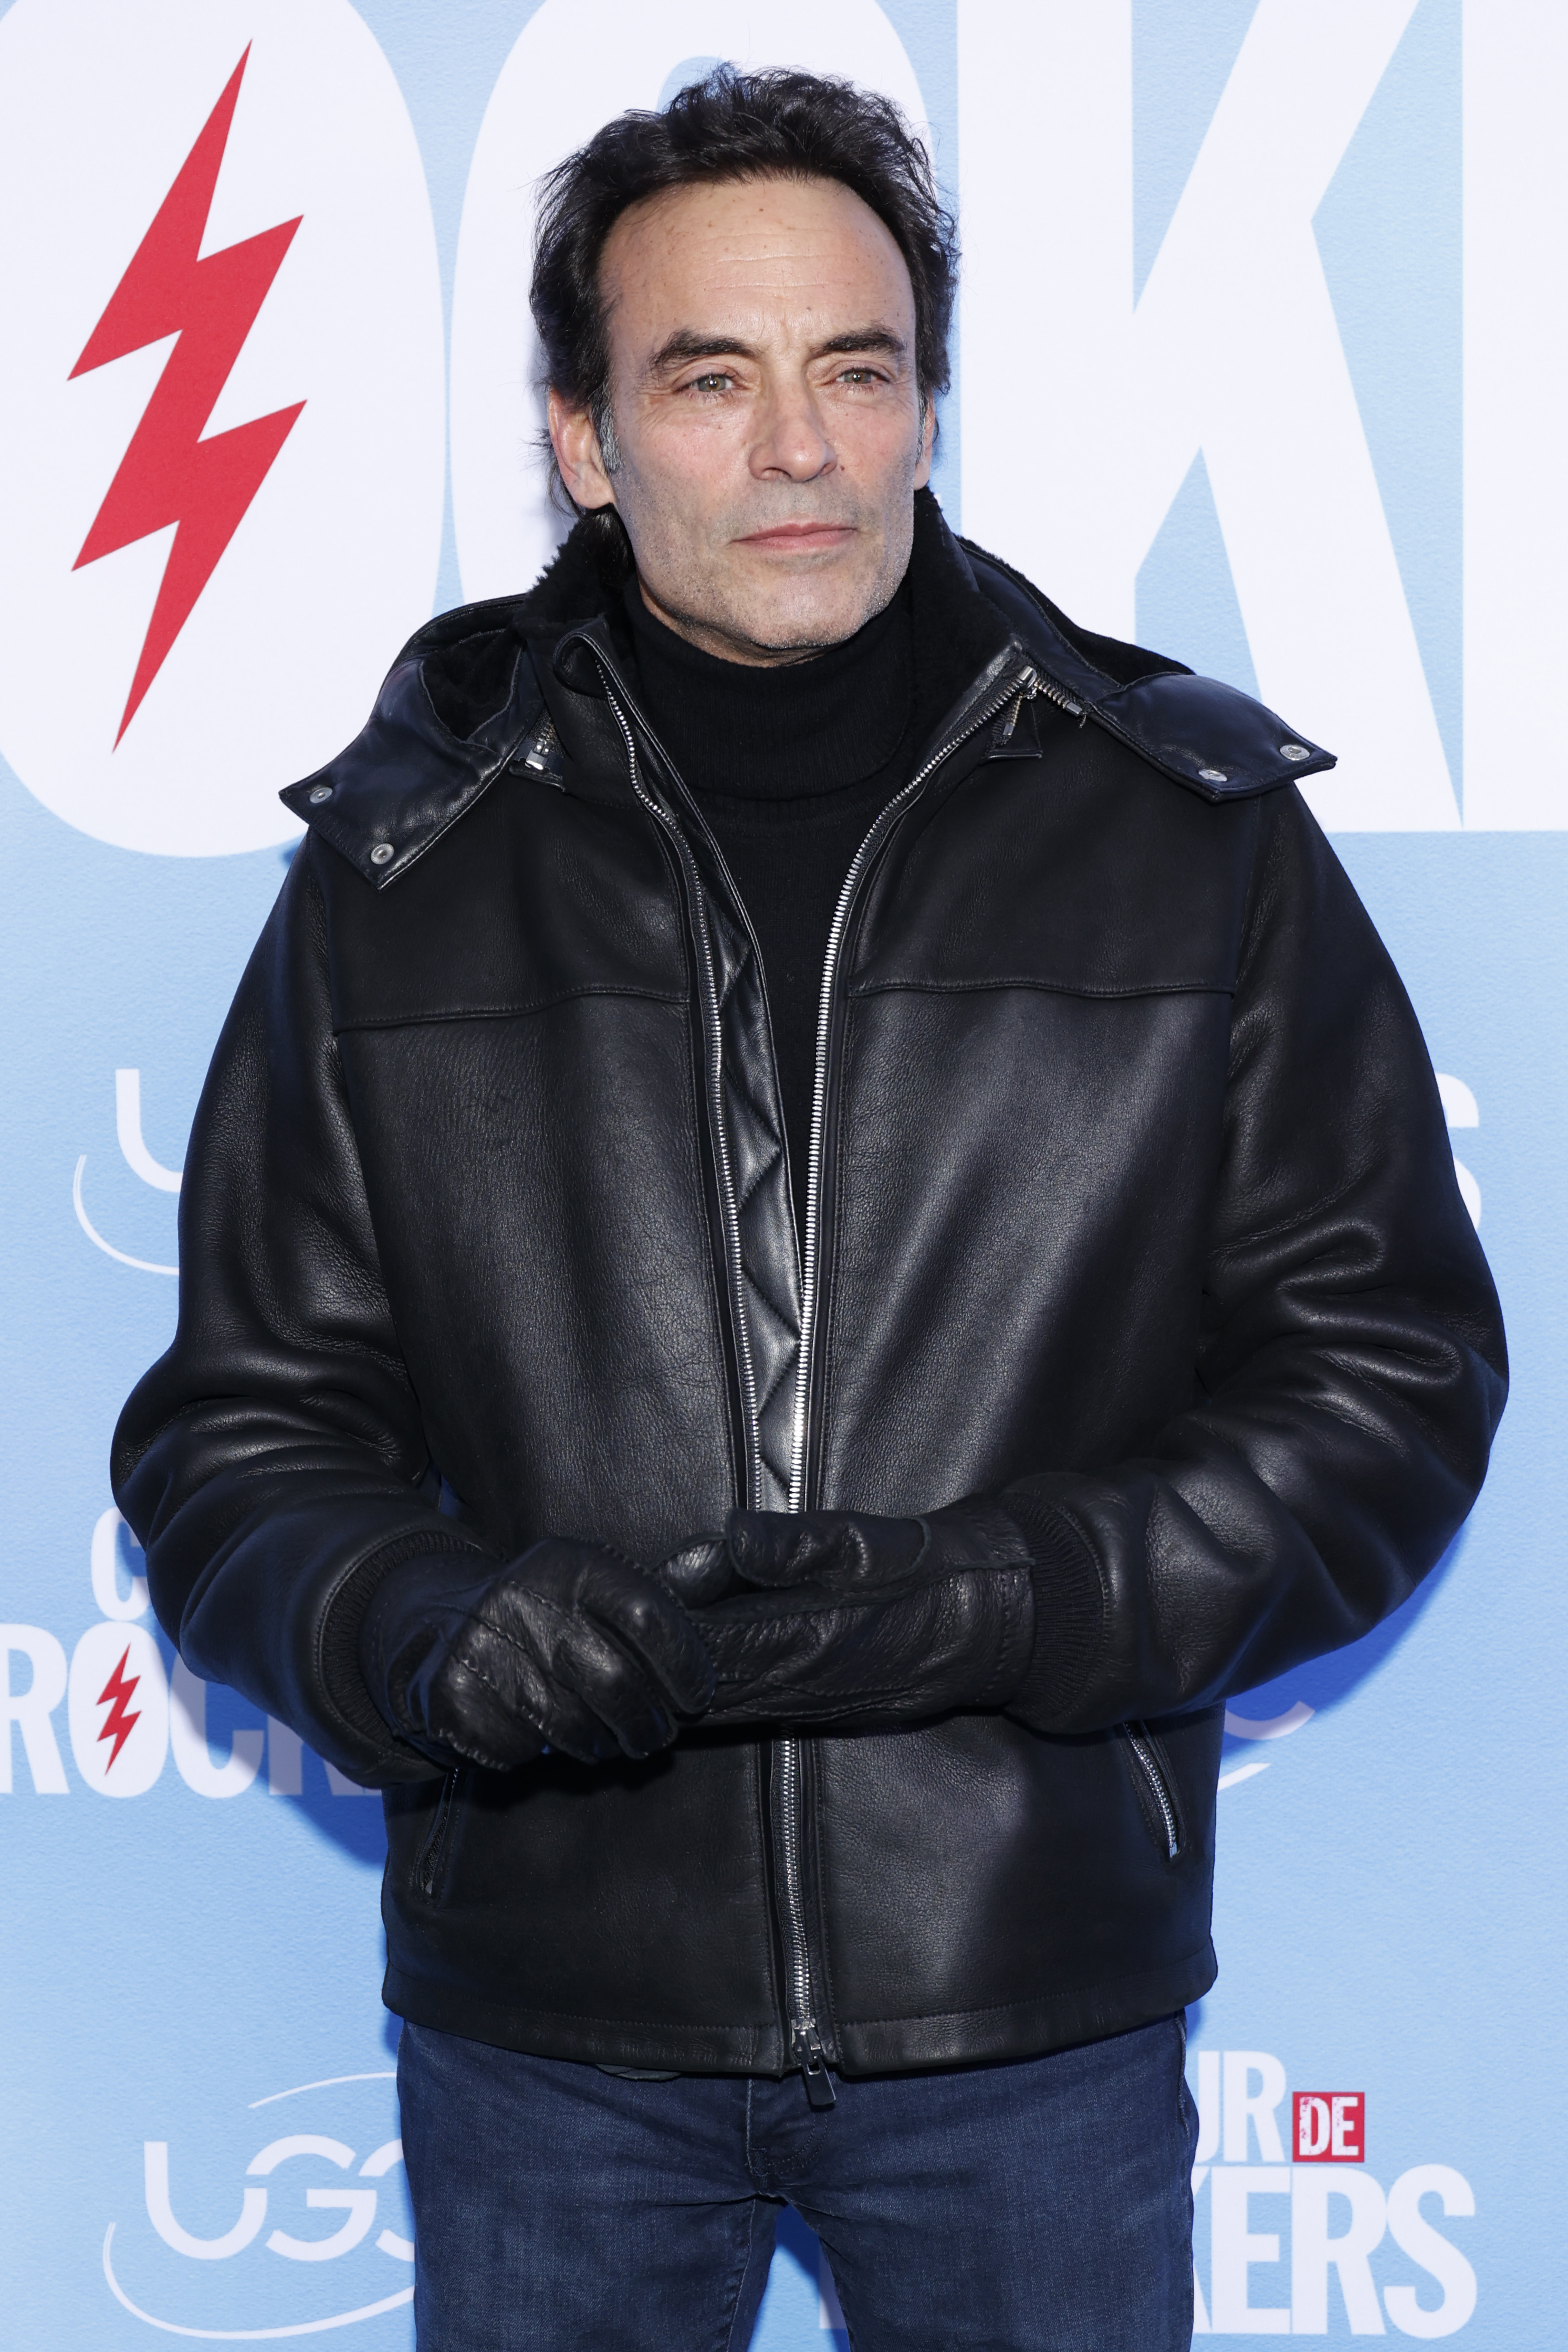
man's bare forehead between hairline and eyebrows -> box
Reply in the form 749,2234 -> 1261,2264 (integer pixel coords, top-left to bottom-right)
600,179 -> 914,341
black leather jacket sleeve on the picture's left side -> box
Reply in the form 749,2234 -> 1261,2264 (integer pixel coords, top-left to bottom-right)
113,840 -> 492,1783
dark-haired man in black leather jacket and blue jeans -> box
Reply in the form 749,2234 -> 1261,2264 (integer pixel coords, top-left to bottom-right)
115,70 -> 1504,2352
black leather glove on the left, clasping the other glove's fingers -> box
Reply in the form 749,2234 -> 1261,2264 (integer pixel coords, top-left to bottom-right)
360,1536 -> 712,1771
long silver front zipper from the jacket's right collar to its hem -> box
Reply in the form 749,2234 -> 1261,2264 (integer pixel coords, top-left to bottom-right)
776,665 -> 1053,2107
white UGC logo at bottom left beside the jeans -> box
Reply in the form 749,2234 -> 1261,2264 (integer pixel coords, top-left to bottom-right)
103,2070 -> 414,2343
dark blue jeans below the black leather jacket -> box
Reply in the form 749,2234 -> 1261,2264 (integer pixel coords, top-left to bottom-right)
398,2018 -> 1197,2352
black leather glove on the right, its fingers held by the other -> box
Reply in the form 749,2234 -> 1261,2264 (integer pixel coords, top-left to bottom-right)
658,1498 -> 1034,1724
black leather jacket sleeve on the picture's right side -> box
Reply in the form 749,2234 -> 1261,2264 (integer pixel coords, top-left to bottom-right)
1004,788 -> 1507,1731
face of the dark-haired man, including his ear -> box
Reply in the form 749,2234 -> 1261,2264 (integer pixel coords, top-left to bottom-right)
550,179 -> 933,663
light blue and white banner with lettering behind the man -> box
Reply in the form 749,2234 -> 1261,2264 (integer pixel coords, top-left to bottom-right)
0,0 -> 1568,2352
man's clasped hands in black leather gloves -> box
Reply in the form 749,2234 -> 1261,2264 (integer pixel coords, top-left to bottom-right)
360,1498 -> 1034,1771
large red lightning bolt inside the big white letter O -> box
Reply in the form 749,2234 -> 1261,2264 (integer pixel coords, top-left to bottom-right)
70,47 -> 306,746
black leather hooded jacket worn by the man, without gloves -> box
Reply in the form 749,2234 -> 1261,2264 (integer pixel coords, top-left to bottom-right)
115,498 -> 1504,2072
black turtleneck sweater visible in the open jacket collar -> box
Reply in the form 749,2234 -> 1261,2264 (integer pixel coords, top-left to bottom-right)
625,581 -> 917,1216
